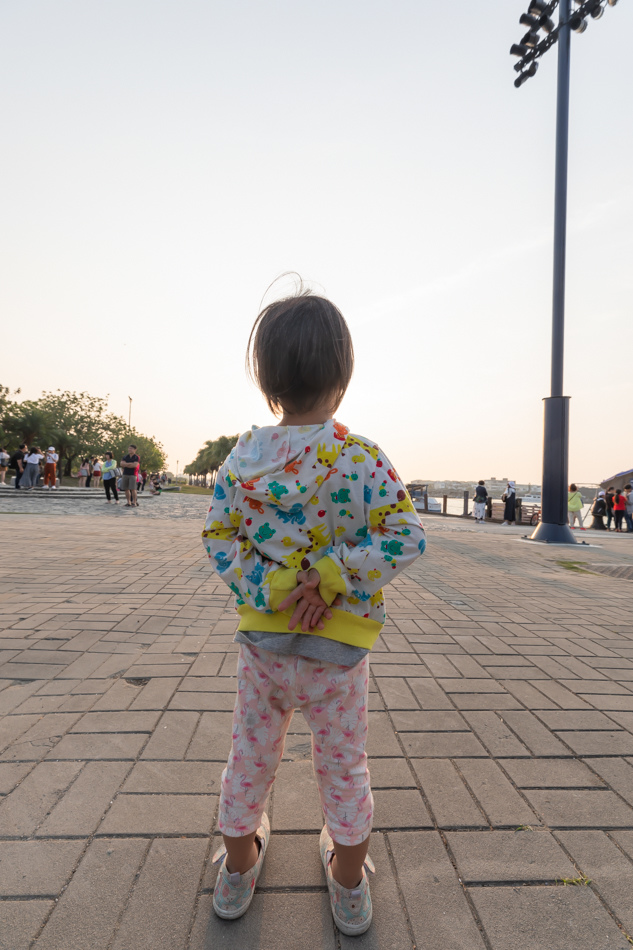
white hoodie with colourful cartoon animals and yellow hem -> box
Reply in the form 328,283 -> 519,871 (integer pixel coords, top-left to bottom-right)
202,419 -> 426,649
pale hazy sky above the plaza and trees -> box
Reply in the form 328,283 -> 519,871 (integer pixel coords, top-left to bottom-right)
0,0 -> 633,484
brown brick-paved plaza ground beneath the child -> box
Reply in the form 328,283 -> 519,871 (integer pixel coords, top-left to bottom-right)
0,514 -> 633,950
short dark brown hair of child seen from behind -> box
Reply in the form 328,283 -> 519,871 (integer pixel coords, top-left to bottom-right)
246,290 -> 354,414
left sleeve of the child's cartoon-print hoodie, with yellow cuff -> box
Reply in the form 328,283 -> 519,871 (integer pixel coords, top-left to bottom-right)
202,452 -> 297,613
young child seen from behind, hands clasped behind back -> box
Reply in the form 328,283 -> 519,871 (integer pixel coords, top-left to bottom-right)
203,292 -> 426,935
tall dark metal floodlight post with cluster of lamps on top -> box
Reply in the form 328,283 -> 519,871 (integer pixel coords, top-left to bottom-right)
510,0 -> 618,544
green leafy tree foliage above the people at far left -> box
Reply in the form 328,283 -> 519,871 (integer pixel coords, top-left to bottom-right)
0,386 -> 166,484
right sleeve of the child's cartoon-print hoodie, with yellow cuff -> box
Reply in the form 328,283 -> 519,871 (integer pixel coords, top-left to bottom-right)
306,451 -> 426,604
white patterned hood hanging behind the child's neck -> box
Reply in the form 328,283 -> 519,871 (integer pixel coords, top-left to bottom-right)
229,419 -> 349,508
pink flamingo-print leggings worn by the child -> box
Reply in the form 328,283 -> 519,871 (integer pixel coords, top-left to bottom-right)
218,644 -> 374,845
